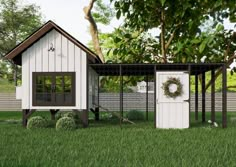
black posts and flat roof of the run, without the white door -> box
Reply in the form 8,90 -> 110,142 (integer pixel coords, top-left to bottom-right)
89,63 -> 227,128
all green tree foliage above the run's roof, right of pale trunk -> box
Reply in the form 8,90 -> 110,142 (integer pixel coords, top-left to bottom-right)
91,0 -> 236,91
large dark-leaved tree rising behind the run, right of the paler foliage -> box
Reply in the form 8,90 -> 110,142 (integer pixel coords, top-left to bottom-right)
112,0 -> 236,88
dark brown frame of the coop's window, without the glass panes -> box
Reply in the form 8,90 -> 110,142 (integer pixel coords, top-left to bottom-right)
32,72 -> 76,106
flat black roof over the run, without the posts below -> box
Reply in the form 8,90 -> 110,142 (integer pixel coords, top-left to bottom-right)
90,63 -> 225,76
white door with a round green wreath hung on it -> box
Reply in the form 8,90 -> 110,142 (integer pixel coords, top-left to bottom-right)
156,72 -> 189,129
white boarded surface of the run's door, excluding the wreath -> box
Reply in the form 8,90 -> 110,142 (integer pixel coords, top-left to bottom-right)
156,72 -> 189,128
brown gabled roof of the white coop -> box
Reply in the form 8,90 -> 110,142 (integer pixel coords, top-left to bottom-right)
5,20 -> 102,63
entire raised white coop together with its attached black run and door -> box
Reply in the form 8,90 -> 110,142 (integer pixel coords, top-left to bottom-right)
6,21 -> 227,128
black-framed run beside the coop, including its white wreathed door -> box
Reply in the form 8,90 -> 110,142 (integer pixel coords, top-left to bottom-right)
88,63 -> 227,128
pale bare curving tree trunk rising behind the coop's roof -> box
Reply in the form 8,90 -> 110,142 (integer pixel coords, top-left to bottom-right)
84,0 -> 104,62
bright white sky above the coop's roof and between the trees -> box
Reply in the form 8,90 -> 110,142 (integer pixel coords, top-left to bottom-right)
23,0 -> 234,45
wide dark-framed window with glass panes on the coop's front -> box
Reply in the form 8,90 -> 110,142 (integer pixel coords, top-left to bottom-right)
33,72 -> 75,106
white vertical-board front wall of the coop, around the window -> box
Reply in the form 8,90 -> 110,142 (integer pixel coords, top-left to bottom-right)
22,29 -> 87,109
